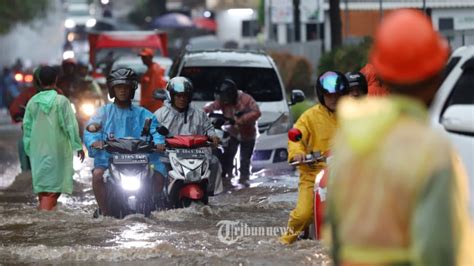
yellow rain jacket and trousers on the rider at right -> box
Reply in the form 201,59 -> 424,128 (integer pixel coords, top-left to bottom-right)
280,104 -> 336,244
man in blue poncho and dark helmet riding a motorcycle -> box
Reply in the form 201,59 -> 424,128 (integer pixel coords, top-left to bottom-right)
84,68 -> 165,217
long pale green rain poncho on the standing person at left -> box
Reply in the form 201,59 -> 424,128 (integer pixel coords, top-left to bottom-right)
23,90 -> 82,193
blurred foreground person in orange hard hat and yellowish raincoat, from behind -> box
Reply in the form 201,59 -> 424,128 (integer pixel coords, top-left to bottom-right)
323,9 -> 474,266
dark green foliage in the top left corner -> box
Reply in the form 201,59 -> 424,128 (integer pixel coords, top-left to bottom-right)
0,0 -> 51,35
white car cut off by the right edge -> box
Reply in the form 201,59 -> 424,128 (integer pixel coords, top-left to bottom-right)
430,46 -> 474,218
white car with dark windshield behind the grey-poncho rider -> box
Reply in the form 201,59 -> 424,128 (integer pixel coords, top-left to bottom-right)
170,49 -> 302,172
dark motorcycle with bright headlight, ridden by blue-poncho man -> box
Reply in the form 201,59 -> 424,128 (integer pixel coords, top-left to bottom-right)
86,119 -> 156,219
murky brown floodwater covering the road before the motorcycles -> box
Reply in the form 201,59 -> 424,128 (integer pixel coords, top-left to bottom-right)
0,120 -> 330,265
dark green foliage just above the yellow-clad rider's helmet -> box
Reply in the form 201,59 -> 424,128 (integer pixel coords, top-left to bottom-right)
318,37 -> 372,73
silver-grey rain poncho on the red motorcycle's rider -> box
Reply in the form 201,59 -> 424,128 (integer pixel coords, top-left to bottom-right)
155,102 -> 216,136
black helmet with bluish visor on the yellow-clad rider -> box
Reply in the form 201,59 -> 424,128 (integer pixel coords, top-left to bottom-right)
316,71 -> 349,106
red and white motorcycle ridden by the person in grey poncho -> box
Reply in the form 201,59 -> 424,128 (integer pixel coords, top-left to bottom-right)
157,126 -> 212,208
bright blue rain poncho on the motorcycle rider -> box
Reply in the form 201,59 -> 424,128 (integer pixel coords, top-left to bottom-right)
84,104 -> 165,173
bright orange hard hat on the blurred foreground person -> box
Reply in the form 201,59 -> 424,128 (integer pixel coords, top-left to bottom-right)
370,9 -> 449,84
